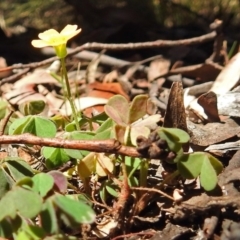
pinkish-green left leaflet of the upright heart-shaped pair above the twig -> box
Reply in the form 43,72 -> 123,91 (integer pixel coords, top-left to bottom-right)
104,95 -> 129,126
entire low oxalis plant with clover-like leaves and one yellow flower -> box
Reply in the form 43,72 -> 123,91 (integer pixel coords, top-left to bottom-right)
0,25 -> 223,240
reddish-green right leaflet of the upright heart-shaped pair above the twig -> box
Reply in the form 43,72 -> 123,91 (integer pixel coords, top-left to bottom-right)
125,95 -> 148,124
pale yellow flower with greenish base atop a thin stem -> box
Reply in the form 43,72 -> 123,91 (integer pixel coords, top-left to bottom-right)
32,25 -> 81,58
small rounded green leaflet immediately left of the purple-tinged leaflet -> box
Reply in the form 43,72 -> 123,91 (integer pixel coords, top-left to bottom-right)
32,173 -> 54,197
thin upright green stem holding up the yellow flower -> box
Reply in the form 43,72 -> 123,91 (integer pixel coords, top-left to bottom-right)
61,58 -> 80,131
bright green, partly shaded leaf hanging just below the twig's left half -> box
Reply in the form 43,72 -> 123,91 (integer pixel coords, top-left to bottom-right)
42,147 -> 70,169
